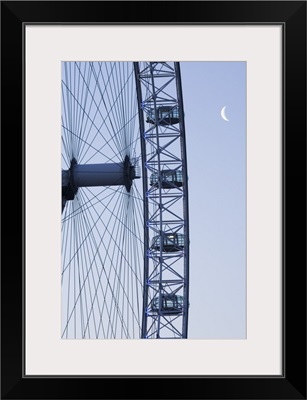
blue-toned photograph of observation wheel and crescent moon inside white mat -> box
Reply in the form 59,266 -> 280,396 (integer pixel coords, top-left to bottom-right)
59,61 -> 247,340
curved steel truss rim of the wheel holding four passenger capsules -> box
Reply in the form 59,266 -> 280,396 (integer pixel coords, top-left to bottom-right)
134,62 -> 189,339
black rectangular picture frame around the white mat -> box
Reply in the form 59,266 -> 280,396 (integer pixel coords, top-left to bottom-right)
1,1 -> 306,399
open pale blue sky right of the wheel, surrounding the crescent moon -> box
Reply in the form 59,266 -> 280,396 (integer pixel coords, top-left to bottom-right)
181,62 -> 246,339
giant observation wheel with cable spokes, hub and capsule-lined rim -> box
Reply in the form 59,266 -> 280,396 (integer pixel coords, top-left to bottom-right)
61,62 -> 189,339
